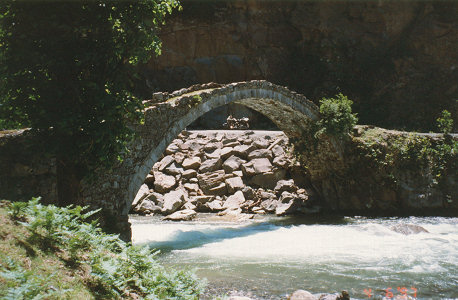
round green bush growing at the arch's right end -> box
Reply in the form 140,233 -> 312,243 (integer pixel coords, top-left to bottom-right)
317,94 -> 358,138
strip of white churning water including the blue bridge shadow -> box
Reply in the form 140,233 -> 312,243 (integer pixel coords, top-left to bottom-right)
132,218 -> 458,265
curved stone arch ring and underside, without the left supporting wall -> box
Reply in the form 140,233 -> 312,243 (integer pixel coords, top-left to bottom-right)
124,80 -> 319,213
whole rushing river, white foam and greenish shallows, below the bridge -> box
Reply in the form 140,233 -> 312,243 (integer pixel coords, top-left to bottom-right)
130,215 -> 458,299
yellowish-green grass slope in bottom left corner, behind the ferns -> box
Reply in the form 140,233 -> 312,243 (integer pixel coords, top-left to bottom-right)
0,201 -> 94,299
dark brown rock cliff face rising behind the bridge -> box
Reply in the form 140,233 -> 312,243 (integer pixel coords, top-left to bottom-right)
143,0 -> 458,130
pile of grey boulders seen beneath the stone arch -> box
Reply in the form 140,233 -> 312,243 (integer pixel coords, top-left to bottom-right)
131,131 -> 311,220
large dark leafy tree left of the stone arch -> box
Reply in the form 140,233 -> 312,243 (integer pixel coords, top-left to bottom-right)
0,0 -> 179,204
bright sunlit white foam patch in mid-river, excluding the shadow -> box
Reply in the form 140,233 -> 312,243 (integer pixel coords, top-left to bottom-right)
176,224 -> 440,263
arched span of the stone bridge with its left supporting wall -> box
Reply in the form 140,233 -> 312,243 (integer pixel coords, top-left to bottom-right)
82,80 -> 339,239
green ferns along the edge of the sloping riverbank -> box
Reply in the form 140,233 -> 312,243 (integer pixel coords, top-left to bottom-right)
0,199 -> 203,299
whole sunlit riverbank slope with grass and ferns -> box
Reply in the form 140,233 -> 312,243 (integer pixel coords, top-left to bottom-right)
0,199 -> 203,300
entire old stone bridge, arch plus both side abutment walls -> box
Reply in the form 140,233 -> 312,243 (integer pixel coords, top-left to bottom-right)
0,80 -> 458,239
